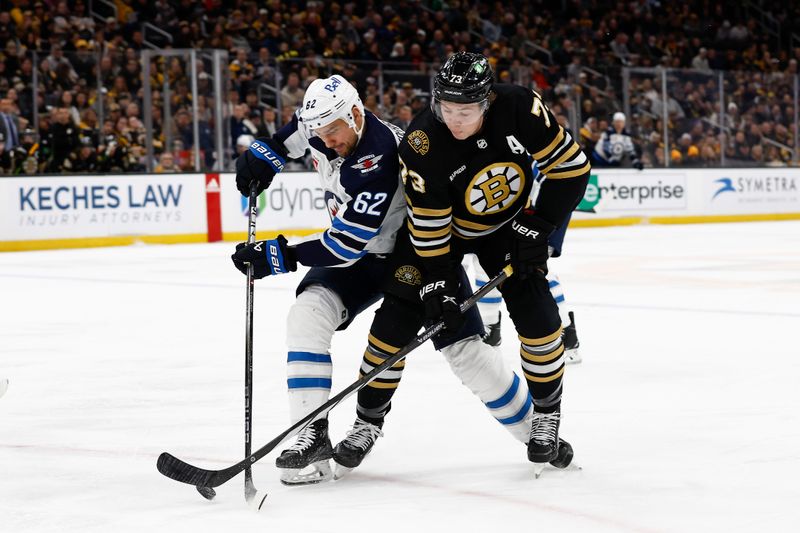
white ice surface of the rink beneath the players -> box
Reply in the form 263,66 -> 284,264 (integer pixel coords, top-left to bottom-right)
0,222 -> 800,533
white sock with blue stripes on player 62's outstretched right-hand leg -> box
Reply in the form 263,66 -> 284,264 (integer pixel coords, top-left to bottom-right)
442,336 -> 533,444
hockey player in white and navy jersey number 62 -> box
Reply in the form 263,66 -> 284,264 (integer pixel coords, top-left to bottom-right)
232,76 -> 544,485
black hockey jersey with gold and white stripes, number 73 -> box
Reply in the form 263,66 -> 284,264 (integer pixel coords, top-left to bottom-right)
399,84 -> 590,266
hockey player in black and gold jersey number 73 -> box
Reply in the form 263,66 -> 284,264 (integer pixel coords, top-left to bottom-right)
333,52 -> 590,475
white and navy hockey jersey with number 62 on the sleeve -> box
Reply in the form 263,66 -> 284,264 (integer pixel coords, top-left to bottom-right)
275,111 -> 406,266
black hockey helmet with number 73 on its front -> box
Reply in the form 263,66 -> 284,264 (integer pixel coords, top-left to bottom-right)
431,52 -> 494,120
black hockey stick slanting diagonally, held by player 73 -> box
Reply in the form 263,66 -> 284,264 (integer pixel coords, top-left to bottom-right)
157,265 -> 513,492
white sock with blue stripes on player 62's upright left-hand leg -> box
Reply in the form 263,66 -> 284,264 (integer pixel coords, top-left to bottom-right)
286,285 -> 344,422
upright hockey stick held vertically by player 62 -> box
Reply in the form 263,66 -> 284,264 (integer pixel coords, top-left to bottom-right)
196,181 -> 267,509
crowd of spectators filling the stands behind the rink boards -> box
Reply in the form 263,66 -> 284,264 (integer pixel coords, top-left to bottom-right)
0,0 -> 800,174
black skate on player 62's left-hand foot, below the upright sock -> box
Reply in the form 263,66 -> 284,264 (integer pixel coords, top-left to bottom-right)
275,419 -> 332,485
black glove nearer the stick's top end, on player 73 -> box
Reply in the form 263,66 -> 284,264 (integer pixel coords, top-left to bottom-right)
511,209 -> 556,279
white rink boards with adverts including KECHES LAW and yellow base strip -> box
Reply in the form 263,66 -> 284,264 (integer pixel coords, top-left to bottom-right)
0,168 -> 800,251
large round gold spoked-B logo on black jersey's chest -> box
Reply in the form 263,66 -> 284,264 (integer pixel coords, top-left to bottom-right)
466,162 -> 525,215
